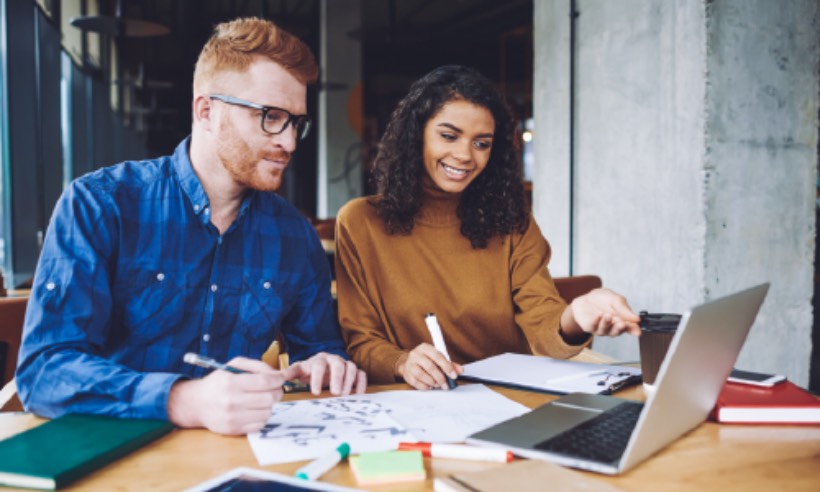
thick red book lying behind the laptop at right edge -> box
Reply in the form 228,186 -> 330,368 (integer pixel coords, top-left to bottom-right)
712,381 -> 820,424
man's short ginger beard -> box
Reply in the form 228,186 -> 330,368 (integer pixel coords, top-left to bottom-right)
217,119 -> 290,191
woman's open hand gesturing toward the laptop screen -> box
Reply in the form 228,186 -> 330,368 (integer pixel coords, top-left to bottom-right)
561,288 -> 641,341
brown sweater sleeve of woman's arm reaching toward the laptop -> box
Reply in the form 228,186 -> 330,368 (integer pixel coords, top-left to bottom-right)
510,217 -> 591,358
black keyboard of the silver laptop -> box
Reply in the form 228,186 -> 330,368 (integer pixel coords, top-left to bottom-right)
535,401 -> 643,463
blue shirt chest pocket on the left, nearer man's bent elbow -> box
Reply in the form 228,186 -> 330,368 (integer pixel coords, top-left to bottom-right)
113,271 -> 186,343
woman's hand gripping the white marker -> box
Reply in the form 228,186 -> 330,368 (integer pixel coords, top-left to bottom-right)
396,343 -> 464,390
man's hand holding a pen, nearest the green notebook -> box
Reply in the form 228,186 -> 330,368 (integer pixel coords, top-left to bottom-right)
168,357 -> 288,435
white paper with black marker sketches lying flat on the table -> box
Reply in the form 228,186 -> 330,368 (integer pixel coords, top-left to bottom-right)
248,384 -> 529,465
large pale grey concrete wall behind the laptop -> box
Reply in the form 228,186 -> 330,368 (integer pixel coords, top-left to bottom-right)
533,0 -> 820,385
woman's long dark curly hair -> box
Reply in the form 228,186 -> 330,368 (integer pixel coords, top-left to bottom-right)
374,65 -> 529,248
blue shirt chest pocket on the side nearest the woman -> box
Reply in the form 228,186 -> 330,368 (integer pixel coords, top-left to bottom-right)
237,276 -> 296,341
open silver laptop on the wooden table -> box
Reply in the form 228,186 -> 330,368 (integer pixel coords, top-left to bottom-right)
467,283 -> 769,475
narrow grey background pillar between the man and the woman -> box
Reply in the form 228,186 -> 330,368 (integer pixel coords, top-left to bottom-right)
316,0 -> 363,218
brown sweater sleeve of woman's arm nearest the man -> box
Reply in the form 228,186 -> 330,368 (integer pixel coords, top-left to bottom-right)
336,202 -> 403,384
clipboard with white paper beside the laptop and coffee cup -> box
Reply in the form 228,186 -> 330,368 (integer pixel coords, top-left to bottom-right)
462,353 -> 641,394
